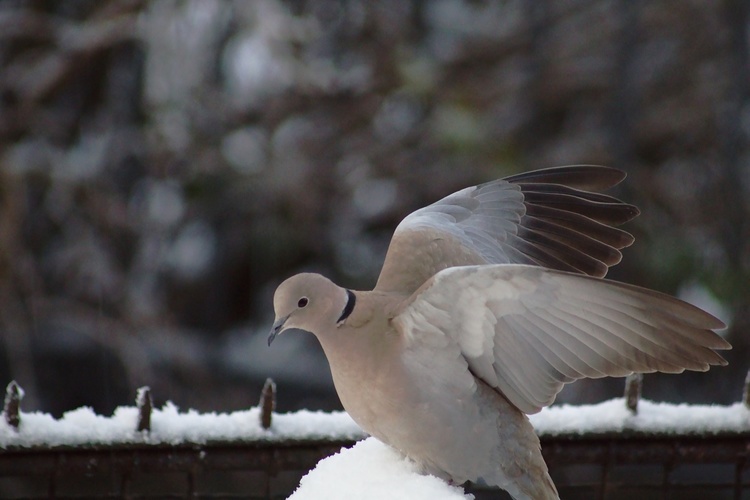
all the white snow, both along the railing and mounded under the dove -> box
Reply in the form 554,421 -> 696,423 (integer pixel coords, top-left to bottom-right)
0,398 -> 750,500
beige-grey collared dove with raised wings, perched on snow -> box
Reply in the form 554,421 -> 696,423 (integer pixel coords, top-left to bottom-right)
268,166 -> 731,500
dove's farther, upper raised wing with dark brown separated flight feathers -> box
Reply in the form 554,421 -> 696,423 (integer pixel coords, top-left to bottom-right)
375,166 -> 638,294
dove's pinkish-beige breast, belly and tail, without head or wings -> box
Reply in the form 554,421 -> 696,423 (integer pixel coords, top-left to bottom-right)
322,292 -> 555,499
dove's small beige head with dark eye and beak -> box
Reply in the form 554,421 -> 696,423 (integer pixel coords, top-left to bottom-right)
268,273 -> 353,345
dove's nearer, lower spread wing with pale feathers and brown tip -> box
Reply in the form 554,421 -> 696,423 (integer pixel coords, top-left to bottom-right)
393,265 -> 731,413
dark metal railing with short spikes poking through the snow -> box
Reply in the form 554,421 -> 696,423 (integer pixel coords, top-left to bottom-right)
0,375 -> 750,500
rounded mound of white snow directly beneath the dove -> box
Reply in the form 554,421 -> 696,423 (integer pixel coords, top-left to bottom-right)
289,438 -> 474,500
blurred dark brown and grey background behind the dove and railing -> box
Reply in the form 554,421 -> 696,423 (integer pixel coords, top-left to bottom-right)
0,0 -> 750,415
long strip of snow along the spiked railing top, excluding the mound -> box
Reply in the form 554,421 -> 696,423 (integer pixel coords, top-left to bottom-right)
0,398 -> 750,449
